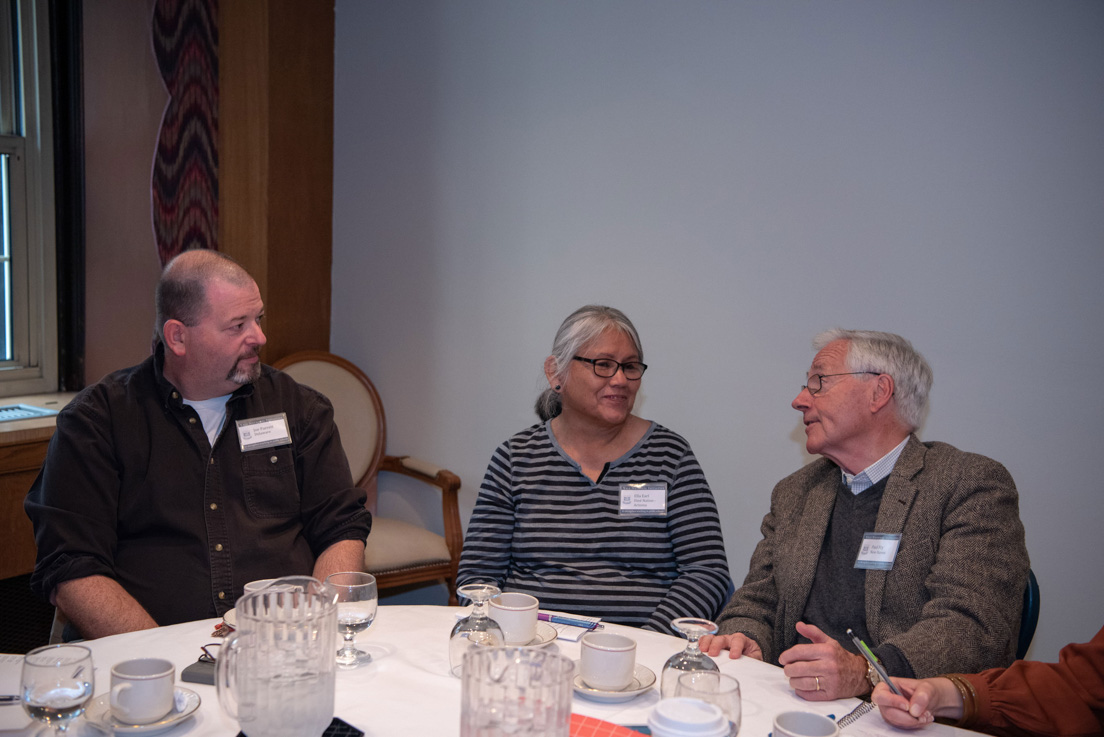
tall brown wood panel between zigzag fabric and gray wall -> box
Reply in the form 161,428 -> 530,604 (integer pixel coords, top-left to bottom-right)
219,0 -> 333,363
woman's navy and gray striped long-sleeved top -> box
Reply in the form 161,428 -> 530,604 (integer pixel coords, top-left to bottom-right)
457,423 -> 730,632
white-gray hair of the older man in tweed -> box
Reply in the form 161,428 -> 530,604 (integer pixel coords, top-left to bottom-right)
813,328 -> 932,430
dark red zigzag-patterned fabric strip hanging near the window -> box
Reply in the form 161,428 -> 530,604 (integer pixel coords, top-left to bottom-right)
150,0 -> 219,266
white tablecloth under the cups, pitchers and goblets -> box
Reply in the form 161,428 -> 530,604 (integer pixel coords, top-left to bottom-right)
3,606 -> 969,737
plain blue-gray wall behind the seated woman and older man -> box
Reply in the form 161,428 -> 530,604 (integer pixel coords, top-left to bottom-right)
332,0 -> 1104,660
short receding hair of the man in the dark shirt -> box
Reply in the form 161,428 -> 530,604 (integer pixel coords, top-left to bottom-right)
153,249 -> 253,341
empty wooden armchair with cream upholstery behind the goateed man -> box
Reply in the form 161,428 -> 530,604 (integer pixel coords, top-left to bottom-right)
273,351 -> 464,605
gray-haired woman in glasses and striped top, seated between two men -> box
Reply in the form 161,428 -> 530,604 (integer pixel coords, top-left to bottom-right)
457,305 -> 730,631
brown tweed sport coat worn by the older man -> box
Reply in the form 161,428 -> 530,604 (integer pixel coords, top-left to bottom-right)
718,435 -> 1029,677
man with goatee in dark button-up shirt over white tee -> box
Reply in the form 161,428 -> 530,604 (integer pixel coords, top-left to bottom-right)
24,250 -> 371,638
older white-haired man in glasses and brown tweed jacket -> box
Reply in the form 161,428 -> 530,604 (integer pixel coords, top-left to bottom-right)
702,330 -> 1029,699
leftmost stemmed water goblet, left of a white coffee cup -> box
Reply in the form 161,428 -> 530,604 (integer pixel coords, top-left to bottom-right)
20,644 -> 96,735
